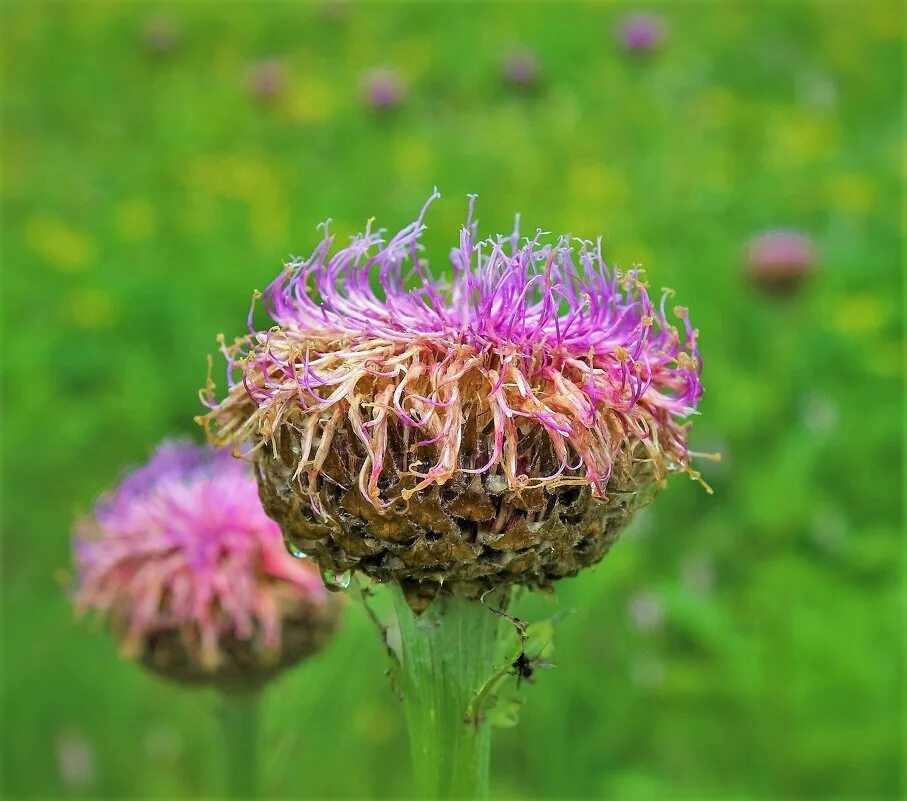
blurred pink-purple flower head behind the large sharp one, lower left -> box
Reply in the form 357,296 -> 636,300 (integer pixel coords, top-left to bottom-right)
73,442 -> 339,691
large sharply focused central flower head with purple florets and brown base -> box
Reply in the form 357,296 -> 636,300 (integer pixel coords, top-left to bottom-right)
199,194 -> 702,609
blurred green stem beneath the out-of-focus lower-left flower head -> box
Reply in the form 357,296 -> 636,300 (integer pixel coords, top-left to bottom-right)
220,692 -> 261,798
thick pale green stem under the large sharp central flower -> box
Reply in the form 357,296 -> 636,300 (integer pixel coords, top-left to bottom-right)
394,587 -> 510,799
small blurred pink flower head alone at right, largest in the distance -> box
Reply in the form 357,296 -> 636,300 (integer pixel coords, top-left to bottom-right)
745,230 -> 817,295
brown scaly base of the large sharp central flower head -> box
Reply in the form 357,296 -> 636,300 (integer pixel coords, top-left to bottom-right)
257,412 -> 658,612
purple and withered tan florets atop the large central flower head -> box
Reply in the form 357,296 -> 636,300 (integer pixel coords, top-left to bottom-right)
202,194 -> 702,512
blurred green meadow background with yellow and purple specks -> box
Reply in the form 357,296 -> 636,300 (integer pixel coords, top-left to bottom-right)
0,0 -> 904,799
